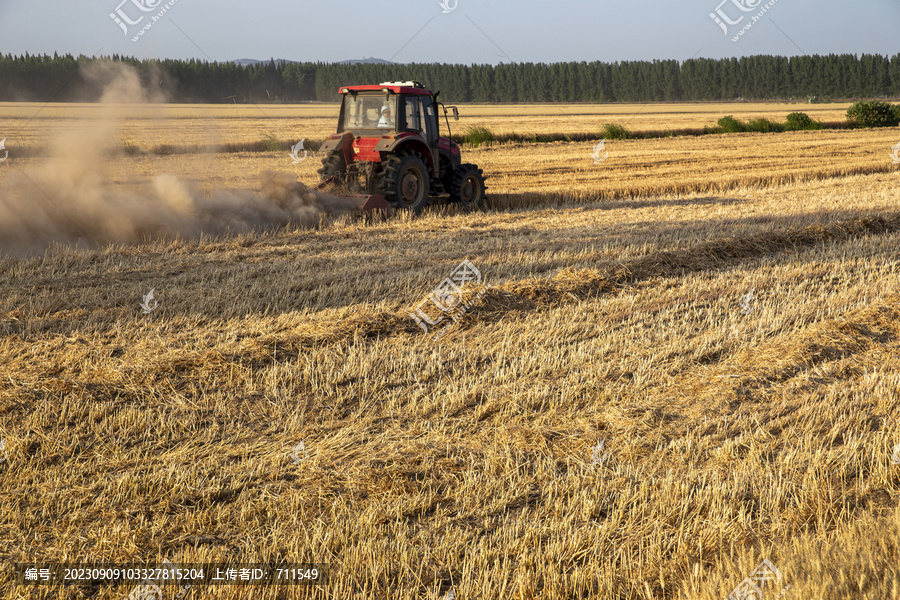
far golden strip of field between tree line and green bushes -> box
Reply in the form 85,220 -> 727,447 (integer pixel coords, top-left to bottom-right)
0,101 -> 849,152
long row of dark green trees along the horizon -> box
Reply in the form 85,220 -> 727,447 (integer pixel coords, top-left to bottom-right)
0,54 -> 900,103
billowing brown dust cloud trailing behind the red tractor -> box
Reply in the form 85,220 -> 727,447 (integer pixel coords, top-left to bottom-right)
0,63 -> 366,254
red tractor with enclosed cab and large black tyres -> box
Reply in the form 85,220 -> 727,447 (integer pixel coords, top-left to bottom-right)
319,81 -> 485,213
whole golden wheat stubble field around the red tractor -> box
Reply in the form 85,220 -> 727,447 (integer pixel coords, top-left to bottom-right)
0,98 -> 900,600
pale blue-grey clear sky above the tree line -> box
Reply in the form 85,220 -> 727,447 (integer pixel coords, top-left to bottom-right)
0,0 -> 900,64
